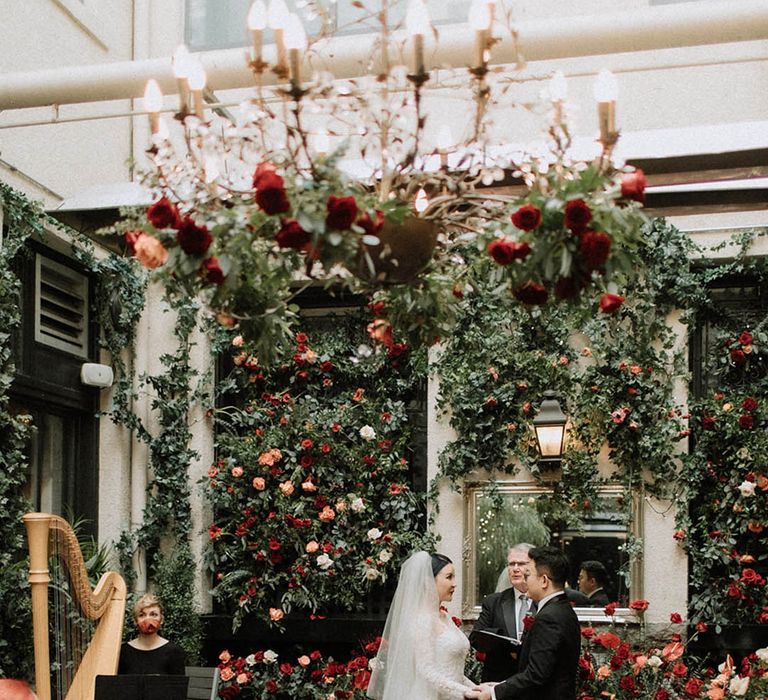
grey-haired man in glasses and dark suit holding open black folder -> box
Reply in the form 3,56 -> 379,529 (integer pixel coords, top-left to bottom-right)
469,543 -> 536,682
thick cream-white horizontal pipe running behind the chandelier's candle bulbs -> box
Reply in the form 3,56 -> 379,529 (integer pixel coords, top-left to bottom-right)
0,0 -> 768,110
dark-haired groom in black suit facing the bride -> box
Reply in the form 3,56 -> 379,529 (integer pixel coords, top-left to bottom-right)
478,547 -> 581,700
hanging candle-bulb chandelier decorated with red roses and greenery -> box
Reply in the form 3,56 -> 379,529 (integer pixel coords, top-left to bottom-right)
120,0 -> 645,362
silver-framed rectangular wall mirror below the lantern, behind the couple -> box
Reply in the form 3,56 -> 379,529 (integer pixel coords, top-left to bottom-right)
462,481 -> 640,619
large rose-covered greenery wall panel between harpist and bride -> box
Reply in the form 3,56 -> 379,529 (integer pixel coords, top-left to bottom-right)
205,323 -> 430,626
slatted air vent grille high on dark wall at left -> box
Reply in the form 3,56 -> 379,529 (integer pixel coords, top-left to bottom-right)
35,255 -> 88,357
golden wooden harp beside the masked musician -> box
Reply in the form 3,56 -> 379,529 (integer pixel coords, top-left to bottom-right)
23,513 -> 126,700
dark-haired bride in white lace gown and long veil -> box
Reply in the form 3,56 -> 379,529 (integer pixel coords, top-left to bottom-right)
368,552 -> 479,700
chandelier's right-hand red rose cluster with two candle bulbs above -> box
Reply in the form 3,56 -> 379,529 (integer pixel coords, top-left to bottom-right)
486,72 -> 648,313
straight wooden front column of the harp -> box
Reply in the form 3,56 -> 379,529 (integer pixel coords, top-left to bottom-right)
23,513 -> 51,700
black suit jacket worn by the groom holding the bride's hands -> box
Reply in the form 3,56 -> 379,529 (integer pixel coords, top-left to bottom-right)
494,595 -> 581,700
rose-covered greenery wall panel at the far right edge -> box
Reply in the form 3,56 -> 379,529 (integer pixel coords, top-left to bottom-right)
675,390 -> 768,631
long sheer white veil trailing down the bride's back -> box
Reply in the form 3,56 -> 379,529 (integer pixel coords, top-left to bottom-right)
368,552 -> 440,700
